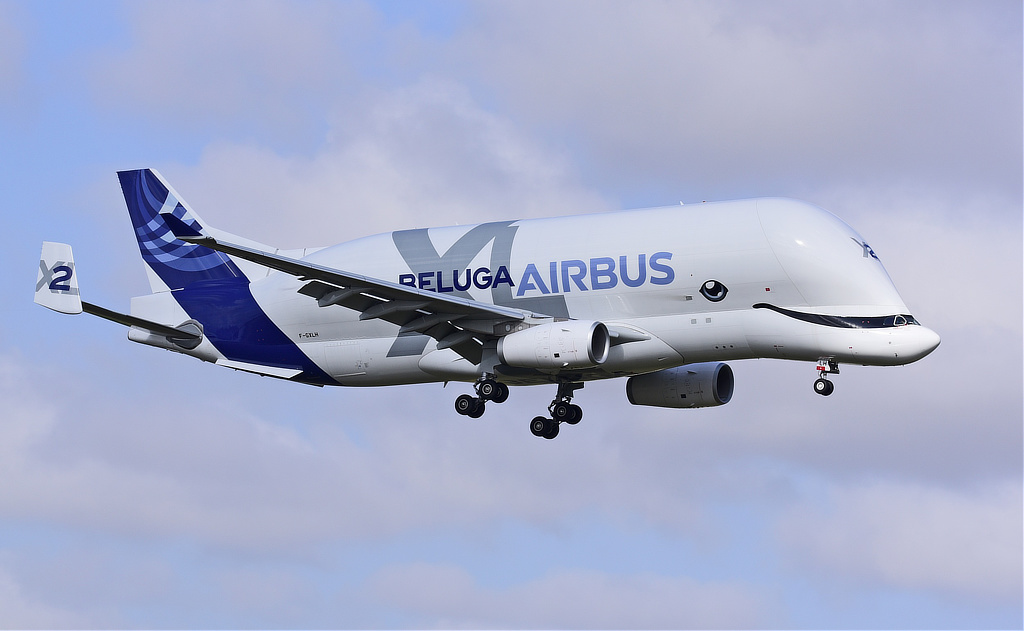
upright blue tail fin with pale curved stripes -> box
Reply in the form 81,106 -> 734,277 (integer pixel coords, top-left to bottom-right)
116,169 -> 246,295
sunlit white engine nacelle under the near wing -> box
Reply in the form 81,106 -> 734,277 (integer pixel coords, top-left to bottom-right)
498,320 -> 611,369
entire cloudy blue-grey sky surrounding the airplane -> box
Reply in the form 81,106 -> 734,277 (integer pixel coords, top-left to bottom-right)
0,0 -> 1024,629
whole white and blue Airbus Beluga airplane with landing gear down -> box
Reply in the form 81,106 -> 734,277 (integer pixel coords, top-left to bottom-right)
35,169 -> 939,438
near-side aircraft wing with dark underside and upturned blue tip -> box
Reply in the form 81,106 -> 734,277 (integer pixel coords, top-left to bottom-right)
162,214 -> 543,364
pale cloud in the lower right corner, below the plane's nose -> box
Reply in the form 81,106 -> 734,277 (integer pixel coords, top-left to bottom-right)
778,481 -> 1024,602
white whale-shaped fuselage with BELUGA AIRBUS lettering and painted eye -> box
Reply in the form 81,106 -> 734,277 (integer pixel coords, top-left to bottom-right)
159,199 -> 938,385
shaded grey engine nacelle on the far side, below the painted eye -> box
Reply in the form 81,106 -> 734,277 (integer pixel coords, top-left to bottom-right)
626,362 -> 735,408
